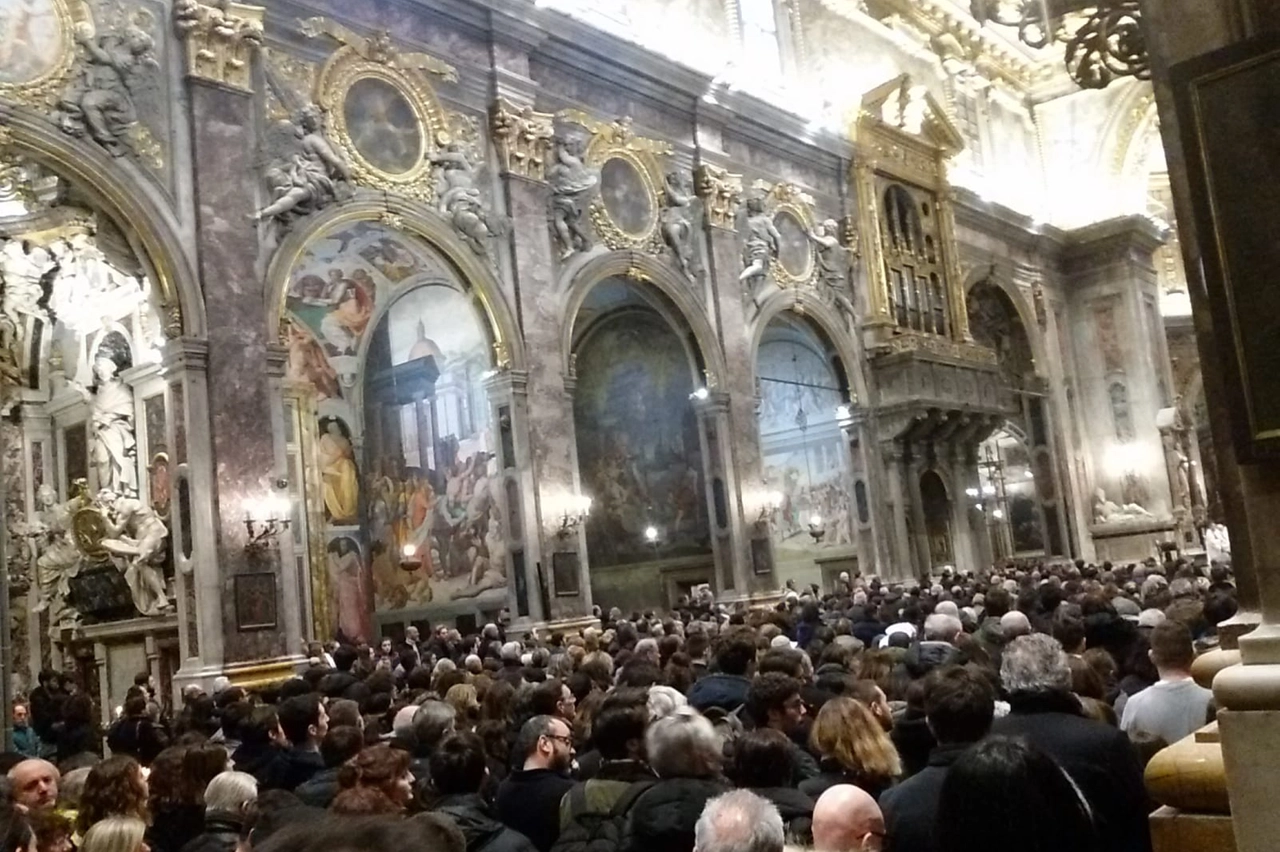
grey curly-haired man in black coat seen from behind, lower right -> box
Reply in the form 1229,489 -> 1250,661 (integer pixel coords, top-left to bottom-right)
991,633 -> 1151,852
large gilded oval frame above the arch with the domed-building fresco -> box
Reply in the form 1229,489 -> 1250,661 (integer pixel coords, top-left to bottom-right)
315,46 -> 449,202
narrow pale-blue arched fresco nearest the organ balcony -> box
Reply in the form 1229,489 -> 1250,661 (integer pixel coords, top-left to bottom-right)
756,317 -> 854,550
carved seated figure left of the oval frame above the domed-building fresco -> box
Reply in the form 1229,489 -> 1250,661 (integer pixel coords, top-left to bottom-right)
253,105 -> 351,221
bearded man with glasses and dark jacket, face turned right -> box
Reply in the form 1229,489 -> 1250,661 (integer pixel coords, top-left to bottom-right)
497,716 -> 573,852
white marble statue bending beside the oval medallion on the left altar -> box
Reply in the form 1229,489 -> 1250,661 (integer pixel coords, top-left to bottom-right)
95,489 -> 172,615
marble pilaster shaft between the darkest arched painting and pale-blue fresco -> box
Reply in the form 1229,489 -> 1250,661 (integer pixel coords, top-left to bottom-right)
705,190 -> 777,596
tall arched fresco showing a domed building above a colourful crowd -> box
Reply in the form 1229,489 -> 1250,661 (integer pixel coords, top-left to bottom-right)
365,285 -> 507,610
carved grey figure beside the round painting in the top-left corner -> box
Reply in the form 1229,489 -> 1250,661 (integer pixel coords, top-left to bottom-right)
59,22 -> 160,156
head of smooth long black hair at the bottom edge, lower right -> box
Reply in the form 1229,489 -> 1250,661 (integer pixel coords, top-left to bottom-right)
934,737 -> 1102,852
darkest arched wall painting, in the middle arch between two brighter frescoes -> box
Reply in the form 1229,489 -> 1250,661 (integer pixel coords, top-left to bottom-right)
573,311 -> 710,567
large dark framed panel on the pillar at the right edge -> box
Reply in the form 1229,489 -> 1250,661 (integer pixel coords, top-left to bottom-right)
1170,36 -> 1280,462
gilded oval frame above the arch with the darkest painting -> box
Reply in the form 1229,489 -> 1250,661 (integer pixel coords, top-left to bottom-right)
557,110 -> 672,255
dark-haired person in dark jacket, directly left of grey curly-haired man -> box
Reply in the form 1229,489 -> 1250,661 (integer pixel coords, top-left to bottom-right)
879,665 -> 996,852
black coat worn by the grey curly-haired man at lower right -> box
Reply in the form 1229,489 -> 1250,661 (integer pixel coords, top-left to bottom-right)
991,692 -> 1151,852
